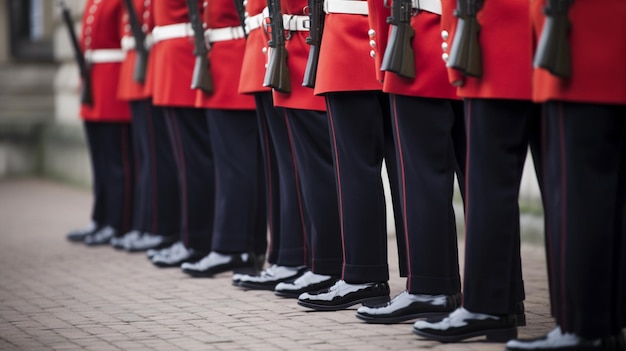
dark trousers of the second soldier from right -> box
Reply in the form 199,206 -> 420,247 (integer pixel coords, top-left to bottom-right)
463,99 -> 541,315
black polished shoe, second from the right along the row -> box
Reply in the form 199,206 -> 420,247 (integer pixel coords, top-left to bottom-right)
413,307 -> 517,342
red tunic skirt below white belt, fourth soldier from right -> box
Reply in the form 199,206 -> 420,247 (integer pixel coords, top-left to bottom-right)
315,0 -> 383,94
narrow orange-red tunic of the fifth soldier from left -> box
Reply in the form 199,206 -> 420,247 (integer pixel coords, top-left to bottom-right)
239,0 -> 270,93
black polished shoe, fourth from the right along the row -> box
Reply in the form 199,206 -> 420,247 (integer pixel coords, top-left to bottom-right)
298,280 -> 389,311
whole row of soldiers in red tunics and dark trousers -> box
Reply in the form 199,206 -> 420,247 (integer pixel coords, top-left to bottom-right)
68,0 -> 626,350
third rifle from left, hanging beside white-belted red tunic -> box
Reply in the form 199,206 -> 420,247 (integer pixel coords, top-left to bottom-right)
187,0 -> 213,93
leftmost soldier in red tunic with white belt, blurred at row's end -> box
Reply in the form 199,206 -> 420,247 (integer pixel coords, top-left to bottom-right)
67,0 -> 134,245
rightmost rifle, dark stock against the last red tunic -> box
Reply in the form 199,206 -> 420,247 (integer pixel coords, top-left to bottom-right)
533,0 -> 573,78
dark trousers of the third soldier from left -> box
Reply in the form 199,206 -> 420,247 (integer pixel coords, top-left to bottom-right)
163,107 -> 215,252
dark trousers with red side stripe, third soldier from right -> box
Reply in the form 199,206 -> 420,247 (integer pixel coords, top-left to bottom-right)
391,95 -> 465,295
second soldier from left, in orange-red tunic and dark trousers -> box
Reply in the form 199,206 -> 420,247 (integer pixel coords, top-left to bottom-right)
111,0 -> 180,251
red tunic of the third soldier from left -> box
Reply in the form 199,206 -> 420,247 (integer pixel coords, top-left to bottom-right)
146,0 -> 202,107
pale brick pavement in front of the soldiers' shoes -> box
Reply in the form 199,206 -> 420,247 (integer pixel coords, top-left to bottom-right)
0,179 -> 553,351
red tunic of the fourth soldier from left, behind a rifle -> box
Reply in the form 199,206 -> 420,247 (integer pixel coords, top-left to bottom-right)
196,0 -> 256,110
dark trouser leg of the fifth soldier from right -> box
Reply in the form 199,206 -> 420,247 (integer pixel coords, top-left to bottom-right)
285,109 -> 343,276
